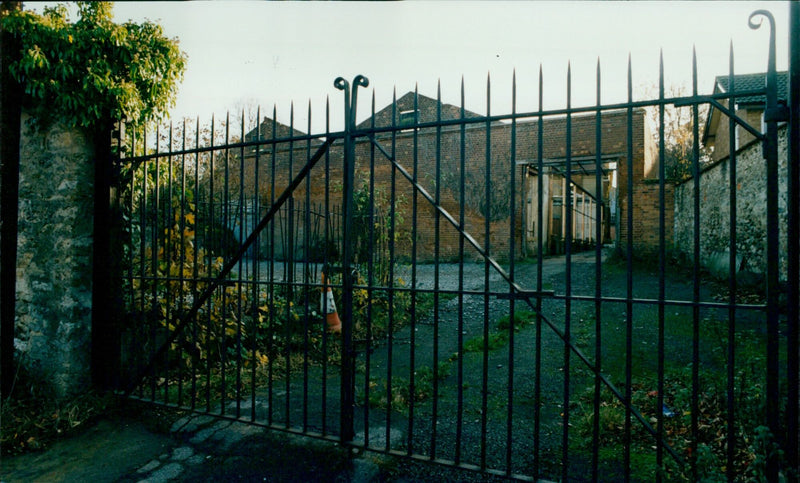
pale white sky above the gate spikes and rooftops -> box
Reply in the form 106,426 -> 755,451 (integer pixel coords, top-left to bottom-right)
25,1 -> 789,132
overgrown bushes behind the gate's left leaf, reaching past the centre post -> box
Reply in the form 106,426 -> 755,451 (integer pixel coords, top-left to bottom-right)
128,170 -> 411,402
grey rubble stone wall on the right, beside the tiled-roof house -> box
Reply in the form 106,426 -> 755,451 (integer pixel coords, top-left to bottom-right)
674,126 -> 788,280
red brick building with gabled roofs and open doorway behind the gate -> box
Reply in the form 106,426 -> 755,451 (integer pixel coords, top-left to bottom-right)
238,93 -> 672,260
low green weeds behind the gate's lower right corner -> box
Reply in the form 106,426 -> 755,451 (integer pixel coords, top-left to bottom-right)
571,292 -> 785,481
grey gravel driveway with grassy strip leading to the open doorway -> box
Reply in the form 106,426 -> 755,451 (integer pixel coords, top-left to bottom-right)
238,251 -> 720,480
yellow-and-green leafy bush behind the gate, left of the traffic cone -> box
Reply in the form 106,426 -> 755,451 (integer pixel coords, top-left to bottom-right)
129,204 -> 316,400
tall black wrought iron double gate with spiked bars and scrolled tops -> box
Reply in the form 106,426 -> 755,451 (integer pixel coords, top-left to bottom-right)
114,11 -> 800,480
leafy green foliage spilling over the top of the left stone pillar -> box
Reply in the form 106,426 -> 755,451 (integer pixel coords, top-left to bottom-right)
2,2 -> 186,128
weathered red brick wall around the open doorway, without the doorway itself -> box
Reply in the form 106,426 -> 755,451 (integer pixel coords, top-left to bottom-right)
236,100 -> 672,260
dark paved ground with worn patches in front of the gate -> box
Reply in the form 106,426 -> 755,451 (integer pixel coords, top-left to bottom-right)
0,403 -> 512,483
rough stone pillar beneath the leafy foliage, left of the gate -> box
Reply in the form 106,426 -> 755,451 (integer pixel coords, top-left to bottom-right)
14,114 -> 94,397
